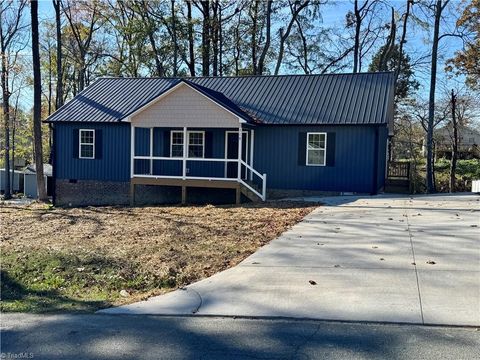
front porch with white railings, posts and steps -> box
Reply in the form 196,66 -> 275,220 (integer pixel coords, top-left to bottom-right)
130,124 -> 266,206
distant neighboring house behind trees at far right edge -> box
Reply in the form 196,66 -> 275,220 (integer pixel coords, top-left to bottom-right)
434,125 -> 480,159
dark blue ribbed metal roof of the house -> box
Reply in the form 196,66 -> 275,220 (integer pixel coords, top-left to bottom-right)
46,72 -> 394,125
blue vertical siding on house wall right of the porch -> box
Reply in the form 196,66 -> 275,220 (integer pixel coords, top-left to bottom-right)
253,125 -> 386,193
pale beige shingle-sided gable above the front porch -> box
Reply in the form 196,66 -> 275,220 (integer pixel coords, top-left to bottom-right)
131,84 -> 239,128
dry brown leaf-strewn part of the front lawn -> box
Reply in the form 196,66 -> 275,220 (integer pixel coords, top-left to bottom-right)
0,202 -> 314,310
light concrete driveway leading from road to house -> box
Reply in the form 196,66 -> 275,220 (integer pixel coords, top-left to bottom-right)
101,195 -> 480,326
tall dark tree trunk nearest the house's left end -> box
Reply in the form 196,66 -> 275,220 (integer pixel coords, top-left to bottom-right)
30,1 -> 48,201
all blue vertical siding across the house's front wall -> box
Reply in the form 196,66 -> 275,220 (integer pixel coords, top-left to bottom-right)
54,123 -> 387,193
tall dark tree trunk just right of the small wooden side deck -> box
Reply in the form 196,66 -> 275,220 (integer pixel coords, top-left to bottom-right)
426,0 -> 442,193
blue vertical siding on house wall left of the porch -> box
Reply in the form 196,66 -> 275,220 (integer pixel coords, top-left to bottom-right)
54,123 -> 130,181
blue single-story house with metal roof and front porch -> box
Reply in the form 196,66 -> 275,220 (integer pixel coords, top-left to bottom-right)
46,72 -> 394,205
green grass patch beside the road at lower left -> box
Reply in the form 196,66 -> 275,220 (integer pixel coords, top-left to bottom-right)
0,251 -> 175,313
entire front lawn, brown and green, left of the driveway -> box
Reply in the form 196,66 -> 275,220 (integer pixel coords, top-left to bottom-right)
0,202 -> 314,312
